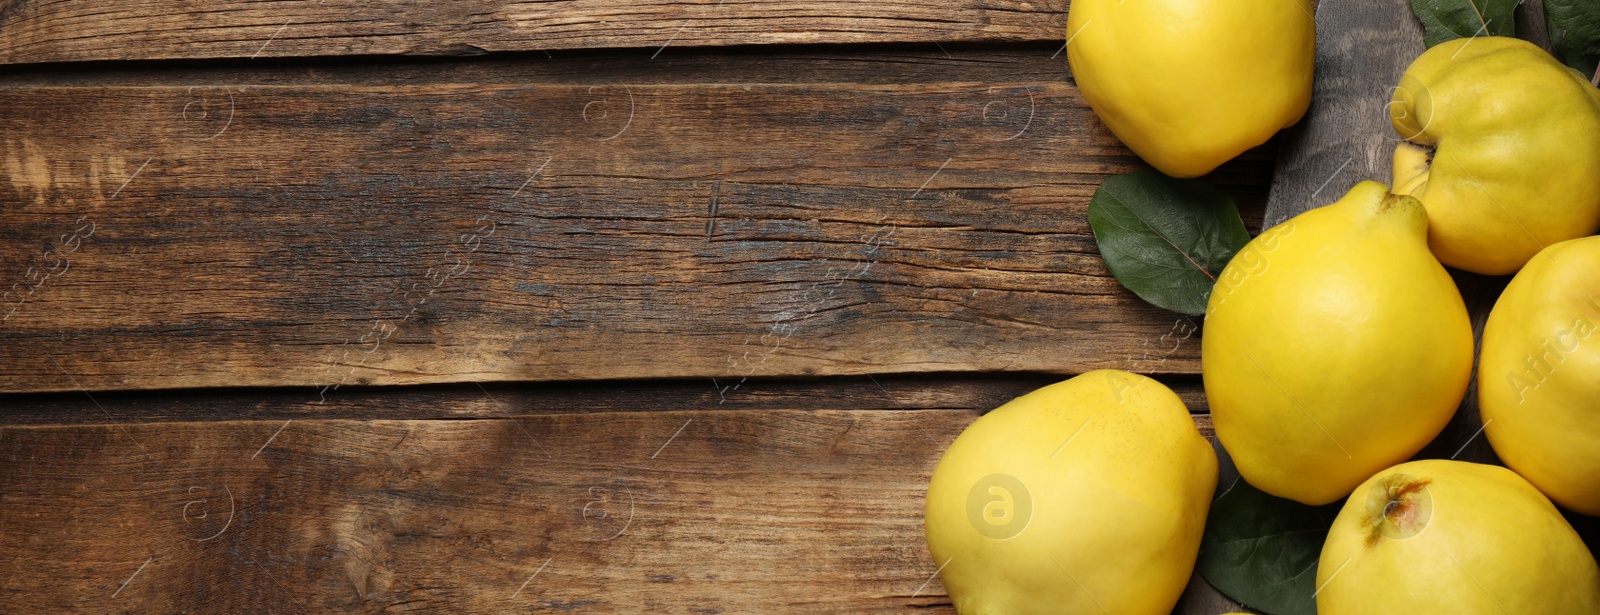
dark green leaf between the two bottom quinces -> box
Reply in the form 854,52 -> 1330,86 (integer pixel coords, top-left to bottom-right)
1195,479 -> 1344,615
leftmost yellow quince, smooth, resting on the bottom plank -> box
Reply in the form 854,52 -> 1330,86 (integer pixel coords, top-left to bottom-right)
925,370 -> 1216,615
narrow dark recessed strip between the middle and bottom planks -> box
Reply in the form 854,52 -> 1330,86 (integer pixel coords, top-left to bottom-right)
0,375 -> 1206,426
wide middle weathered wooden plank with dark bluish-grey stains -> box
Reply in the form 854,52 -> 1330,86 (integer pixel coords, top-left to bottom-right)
0,83 -> 1270,391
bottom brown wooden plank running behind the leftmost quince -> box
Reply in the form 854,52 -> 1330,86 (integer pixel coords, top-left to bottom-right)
0,410 -> 1210,615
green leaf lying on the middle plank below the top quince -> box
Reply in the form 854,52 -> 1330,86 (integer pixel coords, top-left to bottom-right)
1090,170 -> 1250,316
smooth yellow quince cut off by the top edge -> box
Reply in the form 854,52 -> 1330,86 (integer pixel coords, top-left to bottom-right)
1067,0 -> 1317,178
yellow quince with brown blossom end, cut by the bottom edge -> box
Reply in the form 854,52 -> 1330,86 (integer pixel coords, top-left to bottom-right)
1317,460 -> 1600,615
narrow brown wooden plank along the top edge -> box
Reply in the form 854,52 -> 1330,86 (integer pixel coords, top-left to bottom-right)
0,0 -> 1067,64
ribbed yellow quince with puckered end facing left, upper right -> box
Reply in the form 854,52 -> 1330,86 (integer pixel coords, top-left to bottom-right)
1389,37 -> 1600,275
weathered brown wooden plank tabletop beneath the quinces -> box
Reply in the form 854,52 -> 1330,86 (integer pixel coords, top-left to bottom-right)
0,0 -> 1574,615
